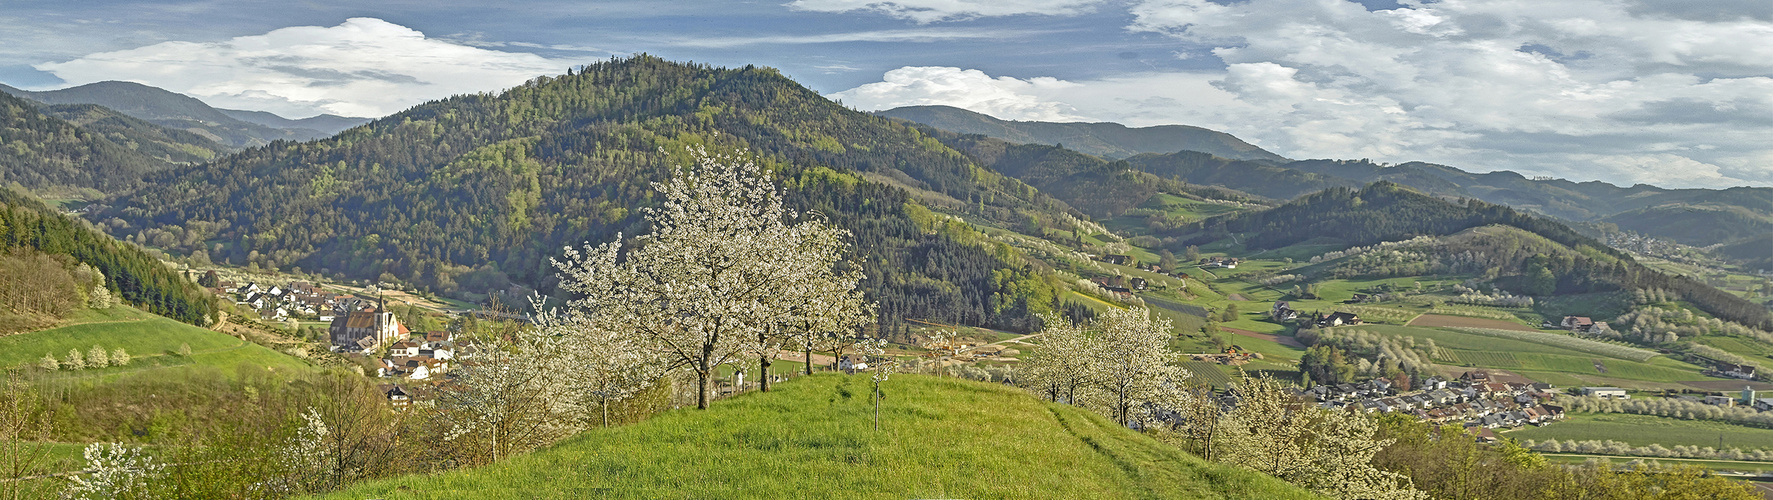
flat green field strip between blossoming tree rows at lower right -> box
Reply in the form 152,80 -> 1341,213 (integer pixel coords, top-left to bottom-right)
1507,413 -> 1773,450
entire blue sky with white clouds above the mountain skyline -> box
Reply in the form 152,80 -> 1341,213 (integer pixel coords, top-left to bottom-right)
0,0 -> 1773,188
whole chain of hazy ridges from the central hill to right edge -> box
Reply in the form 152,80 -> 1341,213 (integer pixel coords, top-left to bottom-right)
876,106 -> 1773,251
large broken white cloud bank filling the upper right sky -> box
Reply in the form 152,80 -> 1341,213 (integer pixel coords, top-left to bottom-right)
1106,0 -> 1773,186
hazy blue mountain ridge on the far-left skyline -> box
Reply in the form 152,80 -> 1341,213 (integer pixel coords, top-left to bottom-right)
0,82 -> 369,149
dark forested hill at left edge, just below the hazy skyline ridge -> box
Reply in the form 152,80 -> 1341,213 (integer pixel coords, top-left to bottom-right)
0,94 -> 192,195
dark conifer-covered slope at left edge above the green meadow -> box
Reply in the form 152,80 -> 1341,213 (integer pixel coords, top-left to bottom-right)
0,190 -> 216,326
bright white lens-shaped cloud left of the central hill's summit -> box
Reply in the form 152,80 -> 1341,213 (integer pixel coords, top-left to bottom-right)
37,18 -> 580,117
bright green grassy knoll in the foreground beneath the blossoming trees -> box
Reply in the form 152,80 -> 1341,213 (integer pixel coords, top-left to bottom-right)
328,374 -> 1312,498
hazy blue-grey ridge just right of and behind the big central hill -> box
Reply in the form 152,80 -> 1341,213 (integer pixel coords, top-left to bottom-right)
874,106 -> 1291,161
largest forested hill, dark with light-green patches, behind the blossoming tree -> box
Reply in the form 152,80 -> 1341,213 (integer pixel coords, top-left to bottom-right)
103,57 -> 1092,328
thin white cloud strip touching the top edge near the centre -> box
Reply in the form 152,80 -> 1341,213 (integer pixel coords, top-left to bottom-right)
787,0 -> 1103,23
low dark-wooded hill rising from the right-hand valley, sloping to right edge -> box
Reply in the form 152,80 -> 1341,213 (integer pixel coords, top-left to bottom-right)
1179,181 -> 1773,328
